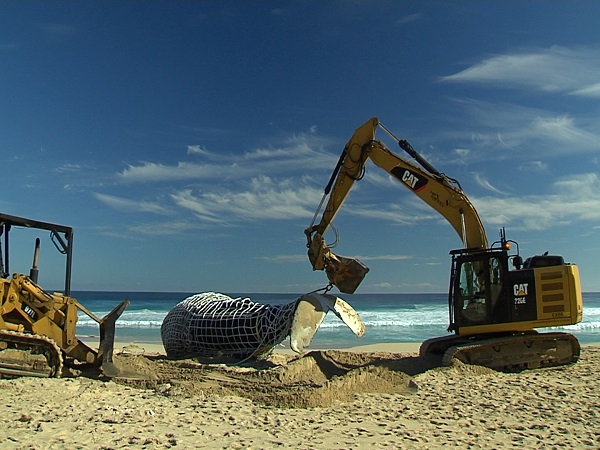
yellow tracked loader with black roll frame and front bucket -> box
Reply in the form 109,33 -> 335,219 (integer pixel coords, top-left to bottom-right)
0,213 -> 129,378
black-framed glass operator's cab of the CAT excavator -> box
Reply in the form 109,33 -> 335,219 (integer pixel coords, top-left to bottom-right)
453,252 -> 507,327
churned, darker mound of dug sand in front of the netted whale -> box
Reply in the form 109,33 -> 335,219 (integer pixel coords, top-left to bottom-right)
109,350 -> 428,408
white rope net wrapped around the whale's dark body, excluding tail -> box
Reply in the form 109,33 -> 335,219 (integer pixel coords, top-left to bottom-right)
161,292 -> 298,360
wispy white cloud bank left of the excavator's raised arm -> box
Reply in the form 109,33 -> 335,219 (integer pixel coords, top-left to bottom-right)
95,129 -> 346,234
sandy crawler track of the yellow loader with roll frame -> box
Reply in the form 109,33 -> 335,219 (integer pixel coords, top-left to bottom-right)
0,330 -> 63,378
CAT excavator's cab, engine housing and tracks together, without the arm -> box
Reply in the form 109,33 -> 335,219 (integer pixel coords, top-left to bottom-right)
440,243 -> 583,370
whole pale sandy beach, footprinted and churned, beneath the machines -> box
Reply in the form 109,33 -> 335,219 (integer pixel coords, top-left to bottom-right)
0,344 -> 600,450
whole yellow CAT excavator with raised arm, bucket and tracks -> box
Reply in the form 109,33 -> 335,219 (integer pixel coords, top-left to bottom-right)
305,118 -> 583,370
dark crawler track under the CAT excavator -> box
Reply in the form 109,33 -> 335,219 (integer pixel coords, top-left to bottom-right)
421,332 -> 580,372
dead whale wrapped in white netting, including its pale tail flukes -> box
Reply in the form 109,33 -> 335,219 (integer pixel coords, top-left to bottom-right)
160,292 -> 365,360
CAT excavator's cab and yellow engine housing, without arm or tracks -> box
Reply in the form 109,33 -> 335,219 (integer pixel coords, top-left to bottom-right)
449,230 -> 583,335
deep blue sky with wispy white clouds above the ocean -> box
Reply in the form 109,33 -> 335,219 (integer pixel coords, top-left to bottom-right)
0,0 -> 600,294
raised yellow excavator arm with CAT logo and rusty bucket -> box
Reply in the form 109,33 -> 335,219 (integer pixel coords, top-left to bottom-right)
304,118 -> 488,293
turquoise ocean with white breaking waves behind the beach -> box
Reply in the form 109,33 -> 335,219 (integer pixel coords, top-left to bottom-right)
72,291 -> 600,349
